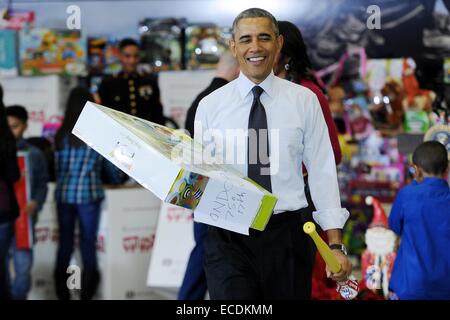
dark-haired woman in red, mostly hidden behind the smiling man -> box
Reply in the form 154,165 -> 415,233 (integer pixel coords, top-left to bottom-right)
274,21 -> 342,299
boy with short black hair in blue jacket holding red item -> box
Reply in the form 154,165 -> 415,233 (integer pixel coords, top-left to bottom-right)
6,105 -> 49,300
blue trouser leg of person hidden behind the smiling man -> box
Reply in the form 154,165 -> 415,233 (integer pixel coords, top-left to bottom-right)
178,222 -> 208,300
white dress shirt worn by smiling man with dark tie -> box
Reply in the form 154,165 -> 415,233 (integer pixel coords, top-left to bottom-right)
194,72 -> 349,230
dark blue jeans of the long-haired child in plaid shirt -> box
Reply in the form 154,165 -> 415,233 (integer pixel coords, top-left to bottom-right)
55,202 -> 100,300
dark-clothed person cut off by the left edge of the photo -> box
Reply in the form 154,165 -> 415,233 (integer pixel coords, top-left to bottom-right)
0,86 -> 20,300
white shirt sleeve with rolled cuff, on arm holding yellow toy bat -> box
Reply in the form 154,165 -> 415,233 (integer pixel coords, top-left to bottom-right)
303,96 -> 350,230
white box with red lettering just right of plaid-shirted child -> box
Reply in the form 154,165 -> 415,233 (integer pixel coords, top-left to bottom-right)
98,187 -> 161,300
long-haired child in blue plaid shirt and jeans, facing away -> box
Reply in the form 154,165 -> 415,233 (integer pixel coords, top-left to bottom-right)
54,87 -> 120,300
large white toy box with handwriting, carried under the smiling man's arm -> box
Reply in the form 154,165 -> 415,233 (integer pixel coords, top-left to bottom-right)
72,102 -> 277,235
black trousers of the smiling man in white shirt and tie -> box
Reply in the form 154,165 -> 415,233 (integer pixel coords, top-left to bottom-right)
205,209 -> 314,300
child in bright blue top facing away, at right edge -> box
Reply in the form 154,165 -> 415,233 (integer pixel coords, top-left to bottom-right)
389,141 -> 450,300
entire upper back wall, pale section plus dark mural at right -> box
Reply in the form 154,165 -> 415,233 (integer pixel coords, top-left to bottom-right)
5,0 -> 450,91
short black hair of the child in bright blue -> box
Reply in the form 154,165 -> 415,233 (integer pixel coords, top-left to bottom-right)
413,141 -> 448,175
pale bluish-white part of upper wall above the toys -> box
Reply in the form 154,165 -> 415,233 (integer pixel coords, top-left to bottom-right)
0,0 -> 310,38
